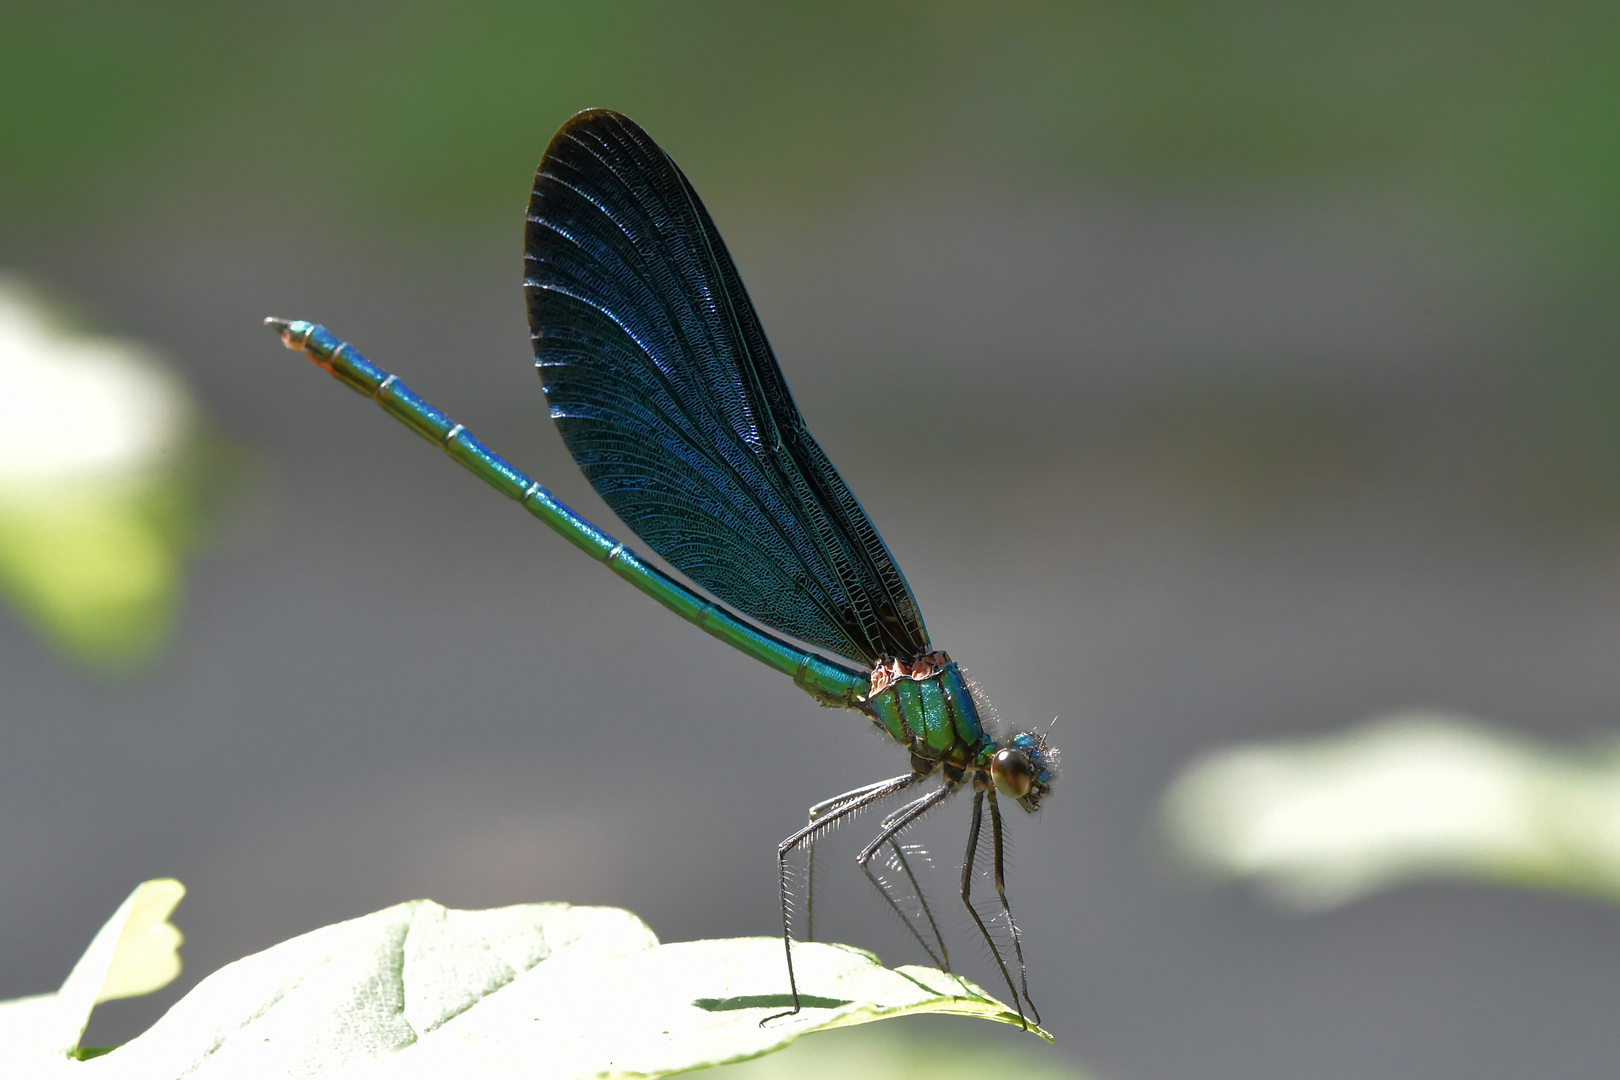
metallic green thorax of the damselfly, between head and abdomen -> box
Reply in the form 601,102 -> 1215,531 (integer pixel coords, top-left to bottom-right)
860,653 -> 995,767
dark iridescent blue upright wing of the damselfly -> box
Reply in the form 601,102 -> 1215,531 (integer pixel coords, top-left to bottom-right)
523,110 -> 928,664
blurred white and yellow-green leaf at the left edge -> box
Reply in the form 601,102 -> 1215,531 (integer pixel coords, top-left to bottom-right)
0,279 -> 228,665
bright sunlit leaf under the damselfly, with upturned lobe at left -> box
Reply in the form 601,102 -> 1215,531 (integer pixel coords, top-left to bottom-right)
0,882 -> 1050,1080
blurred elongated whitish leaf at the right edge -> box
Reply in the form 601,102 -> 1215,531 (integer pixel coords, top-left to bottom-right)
1163,712 -> 1620,910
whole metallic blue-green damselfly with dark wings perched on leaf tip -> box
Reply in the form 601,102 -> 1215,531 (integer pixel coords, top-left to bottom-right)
267,110 -> 1056,1023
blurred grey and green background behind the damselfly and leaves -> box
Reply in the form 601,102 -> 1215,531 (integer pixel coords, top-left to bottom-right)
0,3 -> 1620,1080
